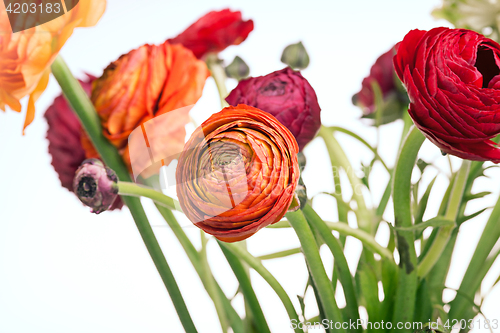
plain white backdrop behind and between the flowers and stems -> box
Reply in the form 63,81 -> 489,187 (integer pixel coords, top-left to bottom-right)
0,0 -> 500,333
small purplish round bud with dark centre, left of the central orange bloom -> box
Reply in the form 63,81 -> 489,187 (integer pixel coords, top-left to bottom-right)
73,158 -> 118,214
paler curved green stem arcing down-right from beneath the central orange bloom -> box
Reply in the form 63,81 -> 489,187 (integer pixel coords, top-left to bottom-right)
215,241 -> 303,333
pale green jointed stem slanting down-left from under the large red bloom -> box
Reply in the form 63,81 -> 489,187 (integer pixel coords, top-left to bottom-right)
418,160 -> 470,279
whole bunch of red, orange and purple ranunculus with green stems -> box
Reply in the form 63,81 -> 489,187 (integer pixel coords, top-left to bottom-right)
0,0 -> 500,333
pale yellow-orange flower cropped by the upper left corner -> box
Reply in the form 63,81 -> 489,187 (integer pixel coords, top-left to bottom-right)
0,0 -> 106,132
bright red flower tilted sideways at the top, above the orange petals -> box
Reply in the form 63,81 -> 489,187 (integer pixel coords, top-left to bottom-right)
169,9 -> 253,59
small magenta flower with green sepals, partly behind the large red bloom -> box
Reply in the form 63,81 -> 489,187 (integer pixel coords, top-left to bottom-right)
352,44 -> 408,124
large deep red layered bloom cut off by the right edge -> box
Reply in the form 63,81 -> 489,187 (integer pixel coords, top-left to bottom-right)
394,28 -> 500,163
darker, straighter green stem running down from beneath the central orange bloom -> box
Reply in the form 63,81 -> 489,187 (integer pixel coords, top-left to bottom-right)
219,242 -> 271,333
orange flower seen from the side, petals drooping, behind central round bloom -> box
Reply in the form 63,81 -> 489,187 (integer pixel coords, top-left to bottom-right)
82,42 -> 210,174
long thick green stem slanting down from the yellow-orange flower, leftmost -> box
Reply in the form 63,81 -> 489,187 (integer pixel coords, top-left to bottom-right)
52,55 -> 197,332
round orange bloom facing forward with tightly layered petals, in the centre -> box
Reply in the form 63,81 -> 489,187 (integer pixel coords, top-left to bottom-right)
176,105 -> 299,242
